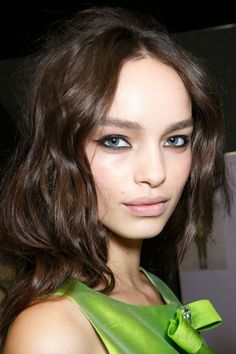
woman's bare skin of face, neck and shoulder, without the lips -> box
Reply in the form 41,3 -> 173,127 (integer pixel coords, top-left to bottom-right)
4,57 -> 192,354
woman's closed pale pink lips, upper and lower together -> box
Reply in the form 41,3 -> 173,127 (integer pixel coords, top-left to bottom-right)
124,196 -> 169,217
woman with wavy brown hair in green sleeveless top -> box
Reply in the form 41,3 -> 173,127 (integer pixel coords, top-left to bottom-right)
0,8 -> 227,354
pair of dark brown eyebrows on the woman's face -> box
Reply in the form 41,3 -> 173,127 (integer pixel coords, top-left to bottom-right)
99,118 -> 193,134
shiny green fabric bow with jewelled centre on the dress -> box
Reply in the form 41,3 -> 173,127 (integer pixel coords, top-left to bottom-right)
167,300 -> 222,354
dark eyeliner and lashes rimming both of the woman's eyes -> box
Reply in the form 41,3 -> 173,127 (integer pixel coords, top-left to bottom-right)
95,135 -> 190,150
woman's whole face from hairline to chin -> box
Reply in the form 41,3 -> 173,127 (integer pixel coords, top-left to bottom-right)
86,57 -> 193,239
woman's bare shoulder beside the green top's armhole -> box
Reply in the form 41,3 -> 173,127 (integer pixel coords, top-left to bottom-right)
3,298 -> 104,354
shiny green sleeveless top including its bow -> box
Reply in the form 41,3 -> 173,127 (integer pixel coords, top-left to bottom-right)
55,268 -> 221,354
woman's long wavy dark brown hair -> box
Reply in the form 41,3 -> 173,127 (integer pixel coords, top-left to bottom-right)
0,8 -> 230,342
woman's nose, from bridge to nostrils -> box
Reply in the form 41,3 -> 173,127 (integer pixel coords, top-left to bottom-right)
134,143 -> 166,188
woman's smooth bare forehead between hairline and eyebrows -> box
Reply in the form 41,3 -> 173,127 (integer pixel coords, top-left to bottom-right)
108,57 -> 191,126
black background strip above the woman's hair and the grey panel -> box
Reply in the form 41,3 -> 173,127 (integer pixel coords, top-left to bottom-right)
0,0 -> 236,59
